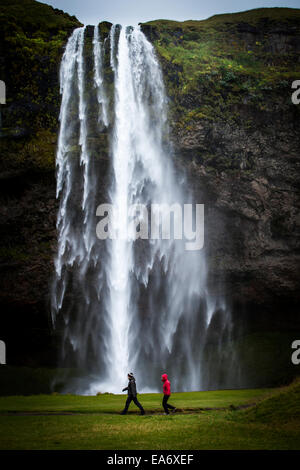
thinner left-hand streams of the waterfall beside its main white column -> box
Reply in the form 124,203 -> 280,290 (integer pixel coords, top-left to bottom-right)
52,28 -> 111,387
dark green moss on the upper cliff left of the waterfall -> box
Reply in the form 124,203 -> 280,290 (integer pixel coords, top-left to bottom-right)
0,0 -> 81,151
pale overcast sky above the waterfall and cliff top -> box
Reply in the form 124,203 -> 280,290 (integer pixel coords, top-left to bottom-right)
40,0 -> 300,25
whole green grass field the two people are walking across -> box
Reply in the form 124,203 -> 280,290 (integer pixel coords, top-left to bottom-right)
0,380 -> 300,450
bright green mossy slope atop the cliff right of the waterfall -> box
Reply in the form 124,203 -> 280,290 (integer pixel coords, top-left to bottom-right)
142,8 -> 300,128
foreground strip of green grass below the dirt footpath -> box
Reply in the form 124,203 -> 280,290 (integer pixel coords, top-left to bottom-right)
0,412 -> 300,450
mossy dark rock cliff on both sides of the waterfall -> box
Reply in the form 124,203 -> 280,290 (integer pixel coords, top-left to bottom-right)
0,0 -> 300,386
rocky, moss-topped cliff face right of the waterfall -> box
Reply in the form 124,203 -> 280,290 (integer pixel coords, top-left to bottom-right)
142,9 -> 300,338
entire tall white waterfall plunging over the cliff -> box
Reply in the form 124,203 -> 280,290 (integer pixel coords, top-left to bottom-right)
52,26 -> 238,394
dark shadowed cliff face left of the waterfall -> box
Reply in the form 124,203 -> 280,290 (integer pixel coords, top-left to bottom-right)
0,0 -> 80,366
